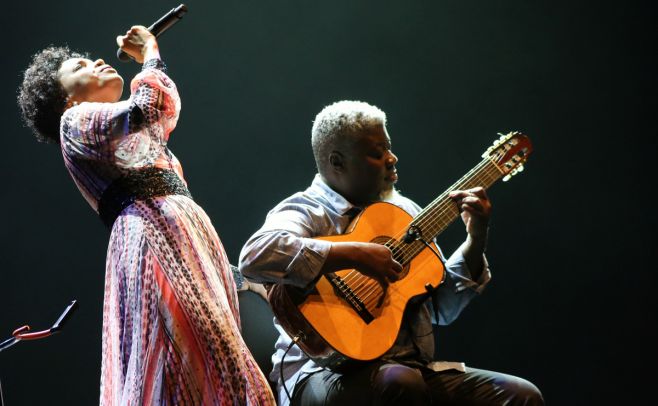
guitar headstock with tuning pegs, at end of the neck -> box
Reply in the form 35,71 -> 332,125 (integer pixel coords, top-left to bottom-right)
482,131 -> 532,182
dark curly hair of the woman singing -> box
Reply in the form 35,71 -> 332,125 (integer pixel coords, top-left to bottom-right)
18,46 -> 87,143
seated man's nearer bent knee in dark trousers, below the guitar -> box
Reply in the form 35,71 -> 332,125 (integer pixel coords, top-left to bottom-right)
373,364 -> 431,406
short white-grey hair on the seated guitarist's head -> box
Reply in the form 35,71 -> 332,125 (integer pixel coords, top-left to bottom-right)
311,100 -> 386,171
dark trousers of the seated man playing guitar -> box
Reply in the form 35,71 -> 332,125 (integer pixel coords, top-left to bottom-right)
291,363 -> 544,406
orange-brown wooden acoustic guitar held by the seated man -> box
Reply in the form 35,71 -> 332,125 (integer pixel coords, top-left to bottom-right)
268,132 -> 532,369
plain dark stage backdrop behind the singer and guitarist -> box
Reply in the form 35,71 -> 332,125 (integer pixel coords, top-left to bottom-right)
0,0 -> 658,406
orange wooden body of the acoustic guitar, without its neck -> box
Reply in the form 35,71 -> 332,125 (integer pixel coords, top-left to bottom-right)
269,203 -> 445,368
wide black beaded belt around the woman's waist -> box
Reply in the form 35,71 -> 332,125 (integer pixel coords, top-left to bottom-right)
98,168 -> 192,228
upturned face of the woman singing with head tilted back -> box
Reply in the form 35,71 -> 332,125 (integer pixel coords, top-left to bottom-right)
57,58 -> 123,107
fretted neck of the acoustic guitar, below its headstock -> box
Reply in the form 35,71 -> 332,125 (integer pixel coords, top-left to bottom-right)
398,159 -> 503,262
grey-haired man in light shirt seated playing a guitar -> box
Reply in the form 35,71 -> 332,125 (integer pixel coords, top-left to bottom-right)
240,101 -> 543,405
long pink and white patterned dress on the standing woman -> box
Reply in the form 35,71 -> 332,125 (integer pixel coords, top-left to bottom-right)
61,59 -> 274,405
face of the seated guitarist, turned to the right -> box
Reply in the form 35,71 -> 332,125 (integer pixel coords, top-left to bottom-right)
342,126 -> 398,205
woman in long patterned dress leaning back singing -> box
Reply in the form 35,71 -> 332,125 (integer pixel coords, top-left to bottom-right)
18,26 -> 274,405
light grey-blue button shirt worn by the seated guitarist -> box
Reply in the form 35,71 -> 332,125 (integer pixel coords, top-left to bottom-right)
239,175 -> 491,405
